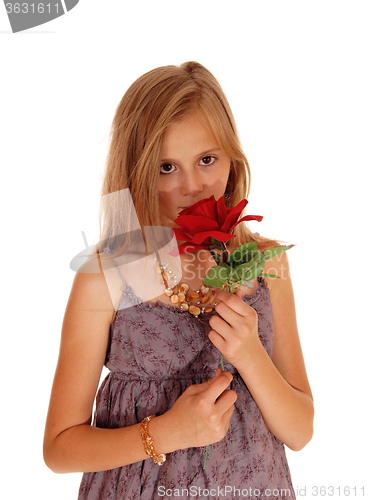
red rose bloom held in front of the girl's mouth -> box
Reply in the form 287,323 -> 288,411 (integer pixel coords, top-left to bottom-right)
174,196 -> 262,253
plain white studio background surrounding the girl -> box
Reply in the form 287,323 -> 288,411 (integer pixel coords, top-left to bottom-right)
0,0 -> 368,500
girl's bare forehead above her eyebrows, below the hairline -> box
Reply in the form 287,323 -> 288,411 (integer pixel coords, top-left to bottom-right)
162,114 -> 219,156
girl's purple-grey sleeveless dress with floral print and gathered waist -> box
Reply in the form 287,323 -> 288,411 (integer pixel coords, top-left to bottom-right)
78,262 -> 295,500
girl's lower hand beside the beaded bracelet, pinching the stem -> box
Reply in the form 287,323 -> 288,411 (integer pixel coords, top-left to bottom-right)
157,368 -> 237,451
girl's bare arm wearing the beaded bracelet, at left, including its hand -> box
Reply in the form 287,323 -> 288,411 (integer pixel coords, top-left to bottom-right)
44,260 -> 236,473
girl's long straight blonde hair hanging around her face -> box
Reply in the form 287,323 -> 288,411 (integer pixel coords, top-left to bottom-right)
96,61 -> 277,256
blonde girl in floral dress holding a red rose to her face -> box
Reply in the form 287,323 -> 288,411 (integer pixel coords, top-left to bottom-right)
44,62 -> 314,500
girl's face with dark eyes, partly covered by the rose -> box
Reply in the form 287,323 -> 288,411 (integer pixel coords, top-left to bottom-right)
158,114 -> 230,227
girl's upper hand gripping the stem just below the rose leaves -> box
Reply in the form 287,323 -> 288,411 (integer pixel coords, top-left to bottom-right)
208,290 -> 260,371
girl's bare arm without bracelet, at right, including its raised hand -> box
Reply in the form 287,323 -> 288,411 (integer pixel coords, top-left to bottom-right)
210,254 -> 314,451
